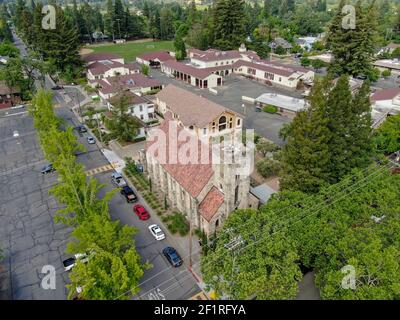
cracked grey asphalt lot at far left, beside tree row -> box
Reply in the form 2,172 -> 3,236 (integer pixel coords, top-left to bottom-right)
0,112 -> 70,299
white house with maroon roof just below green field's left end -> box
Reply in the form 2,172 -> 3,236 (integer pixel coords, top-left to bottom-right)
82,53 -> 140,81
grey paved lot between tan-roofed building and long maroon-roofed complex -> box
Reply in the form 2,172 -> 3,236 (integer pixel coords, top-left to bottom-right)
151,69 -> 296,145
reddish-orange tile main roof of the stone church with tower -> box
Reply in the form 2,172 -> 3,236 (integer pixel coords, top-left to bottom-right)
145,115 -> 214,197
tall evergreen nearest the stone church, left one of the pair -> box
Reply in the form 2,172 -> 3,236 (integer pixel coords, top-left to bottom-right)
281,79 -> 331,193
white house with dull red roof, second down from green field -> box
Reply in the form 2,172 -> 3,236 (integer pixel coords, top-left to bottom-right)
89,73 -> 162,100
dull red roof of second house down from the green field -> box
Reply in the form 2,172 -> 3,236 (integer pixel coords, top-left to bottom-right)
96,73 -> 161,94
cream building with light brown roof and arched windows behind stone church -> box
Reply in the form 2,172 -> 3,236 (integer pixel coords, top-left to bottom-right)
156,84 -> 243,140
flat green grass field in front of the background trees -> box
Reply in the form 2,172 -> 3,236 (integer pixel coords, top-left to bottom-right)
86,41 -> 174,62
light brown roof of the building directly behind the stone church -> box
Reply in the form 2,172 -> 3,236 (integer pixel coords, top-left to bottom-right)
156,84 -> 231,128
